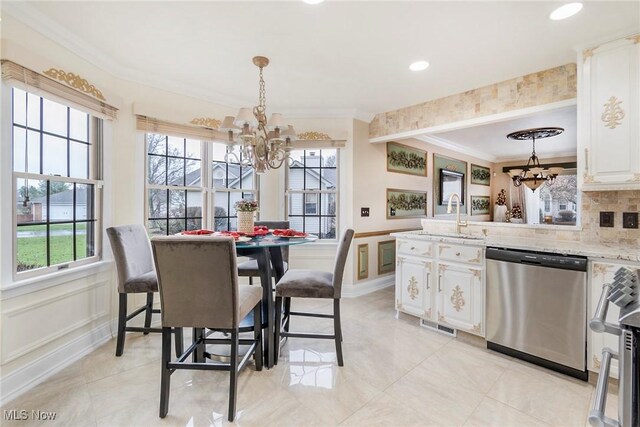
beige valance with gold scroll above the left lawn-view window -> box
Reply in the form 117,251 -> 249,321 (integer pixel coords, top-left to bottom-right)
0,59 -> 118,120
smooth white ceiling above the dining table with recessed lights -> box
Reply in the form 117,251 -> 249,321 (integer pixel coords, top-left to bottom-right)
2,0 -> 640,119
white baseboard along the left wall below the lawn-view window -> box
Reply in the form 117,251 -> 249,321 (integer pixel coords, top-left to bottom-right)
0,322 -> 111,406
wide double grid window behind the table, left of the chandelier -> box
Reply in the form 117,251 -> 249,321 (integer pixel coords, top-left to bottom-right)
145,138 -> 257,235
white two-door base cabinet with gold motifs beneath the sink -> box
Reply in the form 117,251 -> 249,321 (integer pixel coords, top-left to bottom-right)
396,237 -> 485,336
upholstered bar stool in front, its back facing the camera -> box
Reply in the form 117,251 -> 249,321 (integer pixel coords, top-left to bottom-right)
151,236 -> 262,421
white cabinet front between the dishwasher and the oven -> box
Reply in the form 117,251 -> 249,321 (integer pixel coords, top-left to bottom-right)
587,262 -> 623,378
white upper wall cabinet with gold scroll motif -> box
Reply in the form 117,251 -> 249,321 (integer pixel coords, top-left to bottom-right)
578,35 -> 640,191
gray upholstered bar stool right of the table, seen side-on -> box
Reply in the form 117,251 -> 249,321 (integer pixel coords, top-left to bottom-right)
275,229 -> 353,366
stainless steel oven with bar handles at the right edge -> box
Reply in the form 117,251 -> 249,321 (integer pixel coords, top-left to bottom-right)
589,267 -> 640,427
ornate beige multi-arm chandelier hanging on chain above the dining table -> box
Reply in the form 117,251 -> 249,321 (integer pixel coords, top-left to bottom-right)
219,56 -> 296,173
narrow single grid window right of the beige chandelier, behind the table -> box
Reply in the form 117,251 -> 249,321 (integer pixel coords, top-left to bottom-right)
286,149 -> 338,239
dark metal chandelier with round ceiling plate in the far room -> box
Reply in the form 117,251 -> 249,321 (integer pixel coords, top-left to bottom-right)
507,127 -> 564,192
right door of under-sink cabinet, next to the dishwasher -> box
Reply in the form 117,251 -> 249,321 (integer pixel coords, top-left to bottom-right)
437,263 -> 484,336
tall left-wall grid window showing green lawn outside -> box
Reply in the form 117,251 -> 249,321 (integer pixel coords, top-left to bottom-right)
11,88 -> 102,273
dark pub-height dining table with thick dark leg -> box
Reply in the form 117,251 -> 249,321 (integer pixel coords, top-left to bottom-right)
231,233 -> 318,368
